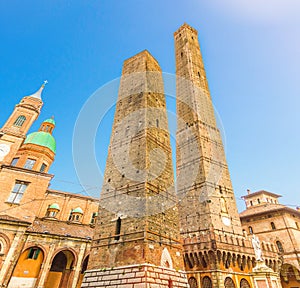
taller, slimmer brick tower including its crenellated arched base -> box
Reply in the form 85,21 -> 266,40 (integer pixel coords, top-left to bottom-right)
174,24 -> 255,287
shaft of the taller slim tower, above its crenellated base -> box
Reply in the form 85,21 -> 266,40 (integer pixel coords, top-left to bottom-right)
175,24 -> 242,238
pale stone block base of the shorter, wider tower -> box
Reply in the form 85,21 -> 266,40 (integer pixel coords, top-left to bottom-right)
81,264 -> 188,288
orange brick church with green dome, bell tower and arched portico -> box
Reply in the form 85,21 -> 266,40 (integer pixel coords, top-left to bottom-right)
0,85 -> 98,288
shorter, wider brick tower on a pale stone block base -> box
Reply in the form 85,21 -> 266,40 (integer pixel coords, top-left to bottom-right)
82,51 -> 187,288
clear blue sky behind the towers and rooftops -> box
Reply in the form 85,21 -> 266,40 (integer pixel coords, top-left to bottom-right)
0,0 -> 300,210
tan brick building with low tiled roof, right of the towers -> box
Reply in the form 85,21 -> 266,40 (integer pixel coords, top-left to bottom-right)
240,190 -> 300,288
